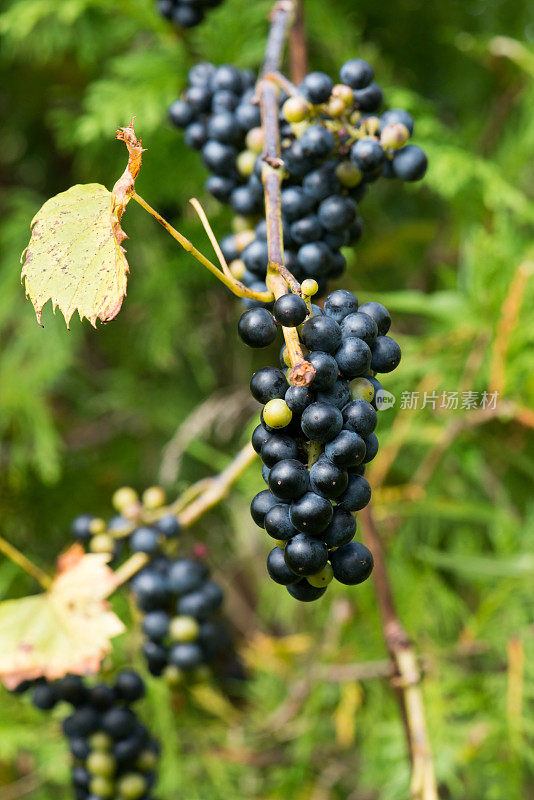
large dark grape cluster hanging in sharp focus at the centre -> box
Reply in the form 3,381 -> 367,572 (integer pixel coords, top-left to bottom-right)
245,289 -> 401,601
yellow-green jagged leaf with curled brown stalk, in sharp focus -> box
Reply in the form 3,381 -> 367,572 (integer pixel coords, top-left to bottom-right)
21,120 -> 144,328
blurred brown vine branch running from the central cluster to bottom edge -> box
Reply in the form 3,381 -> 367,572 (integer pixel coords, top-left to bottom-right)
360,506 -> 438,800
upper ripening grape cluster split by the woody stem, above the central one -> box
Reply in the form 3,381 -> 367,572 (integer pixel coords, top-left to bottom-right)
169,58 -> 427,296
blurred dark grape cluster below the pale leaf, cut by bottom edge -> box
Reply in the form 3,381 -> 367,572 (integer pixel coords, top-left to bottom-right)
24,669 -> 159,800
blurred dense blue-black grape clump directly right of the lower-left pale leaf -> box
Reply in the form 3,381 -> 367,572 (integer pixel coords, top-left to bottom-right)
131,557 -> 231,687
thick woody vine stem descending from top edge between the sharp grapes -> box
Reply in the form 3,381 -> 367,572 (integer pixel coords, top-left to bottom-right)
257,0 -> 315,386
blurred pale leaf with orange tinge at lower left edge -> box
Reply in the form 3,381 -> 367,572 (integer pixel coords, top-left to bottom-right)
0,544 -> 124,689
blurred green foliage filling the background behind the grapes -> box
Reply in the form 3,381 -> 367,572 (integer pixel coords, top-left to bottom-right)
0,0 -> 534,800
